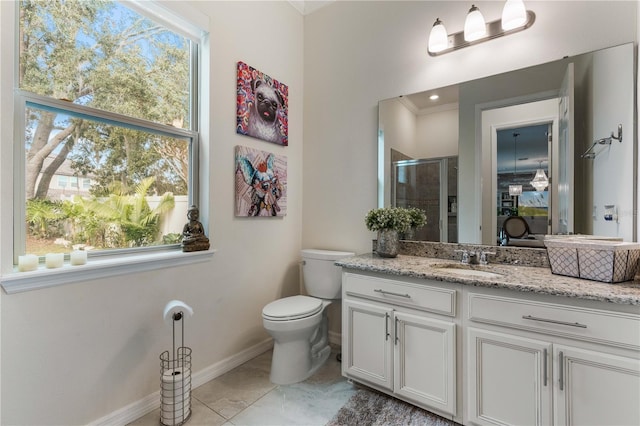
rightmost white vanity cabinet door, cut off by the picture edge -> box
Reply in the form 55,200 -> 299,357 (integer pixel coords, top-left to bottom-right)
553,345 -> 640,426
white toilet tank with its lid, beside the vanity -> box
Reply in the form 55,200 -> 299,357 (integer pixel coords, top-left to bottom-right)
302,249 -> 355,299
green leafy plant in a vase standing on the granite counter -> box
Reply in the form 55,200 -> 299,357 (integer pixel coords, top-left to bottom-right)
364,207 -> 411,257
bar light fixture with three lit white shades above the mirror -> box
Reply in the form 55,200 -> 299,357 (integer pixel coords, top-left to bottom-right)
427,0 -> 536,56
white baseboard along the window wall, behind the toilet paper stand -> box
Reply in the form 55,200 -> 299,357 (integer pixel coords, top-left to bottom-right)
89,338 -> 273,426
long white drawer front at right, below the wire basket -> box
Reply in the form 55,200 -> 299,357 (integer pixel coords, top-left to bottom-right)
469,293 -> 640,350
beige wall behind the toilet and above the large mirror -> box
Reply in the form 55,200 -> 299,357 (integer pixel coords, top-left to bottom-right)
302,1 -> 638,252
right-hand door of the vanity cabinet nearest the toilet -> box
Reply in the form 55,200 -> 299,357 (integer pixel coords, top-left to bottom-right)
394,312 -> 456,415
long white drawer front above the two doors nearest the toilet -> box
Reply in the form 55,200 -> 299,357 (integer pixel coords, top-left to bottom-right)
342,272 -> 456,317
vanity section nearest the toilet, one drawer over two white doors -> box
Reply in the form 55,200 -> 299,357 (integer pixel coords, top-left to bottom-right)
342,272 -> 459,417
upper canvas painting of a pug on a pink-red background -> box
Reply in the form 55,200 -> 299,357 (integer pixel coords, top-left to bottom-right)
236,62 -> 289,146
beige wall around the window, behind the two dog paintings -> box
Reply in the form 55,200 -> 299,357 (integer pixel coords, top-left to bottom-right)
0,1 -> 303,425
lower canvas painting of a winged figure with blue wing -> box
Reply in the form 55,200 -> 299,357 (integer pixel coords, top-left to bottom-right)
236,146 -> 287,216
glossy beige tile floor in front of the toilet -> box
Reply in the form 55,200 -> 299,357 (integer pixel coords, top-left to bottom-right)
129,349 -> 356,426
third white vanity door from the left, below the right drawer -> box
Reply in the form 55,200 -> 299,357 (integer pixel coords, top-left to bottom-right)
466,327 -> 553,425
